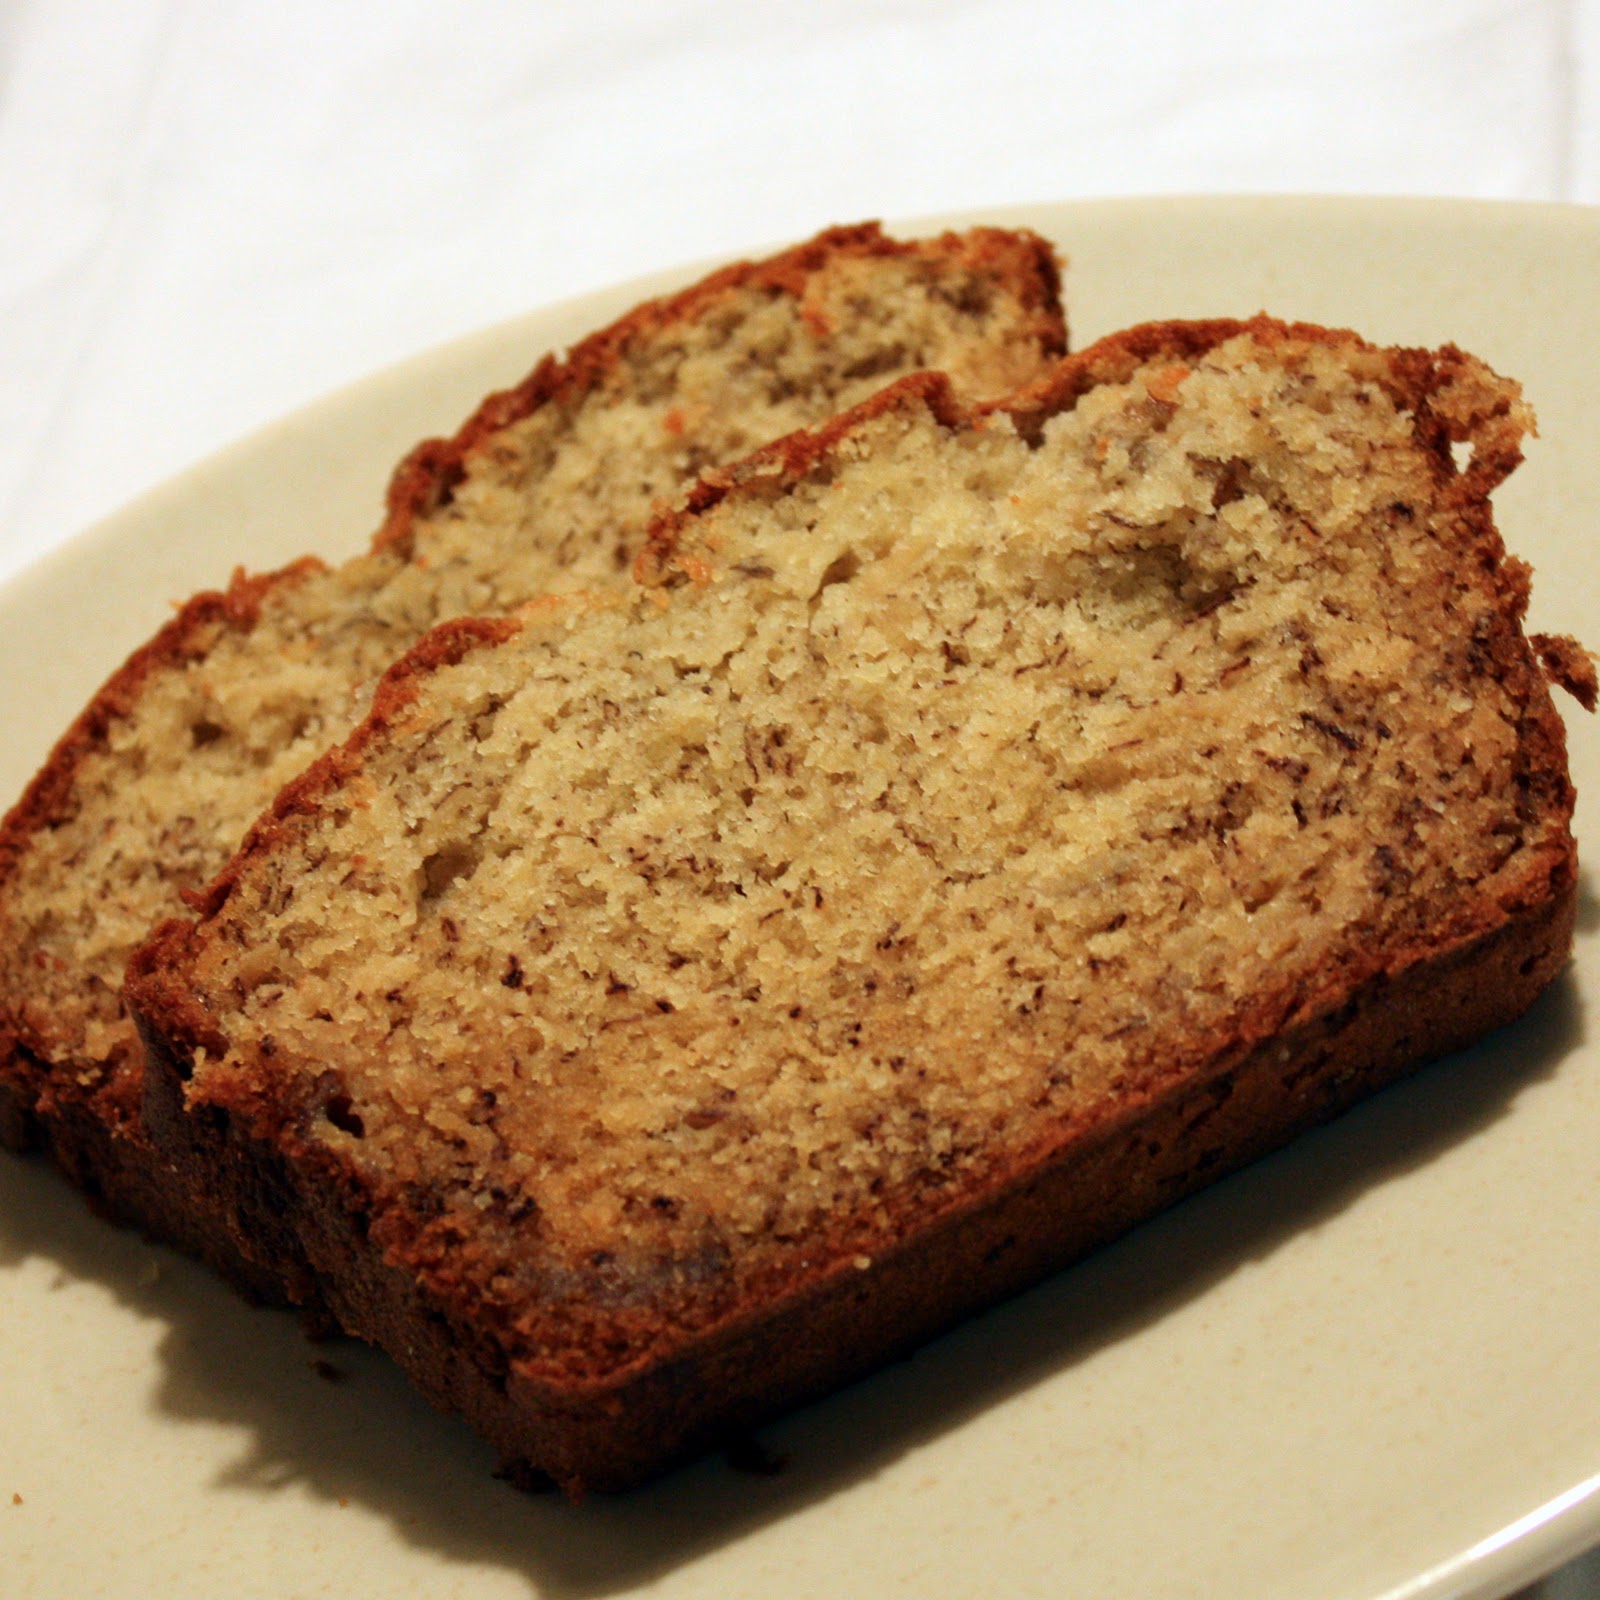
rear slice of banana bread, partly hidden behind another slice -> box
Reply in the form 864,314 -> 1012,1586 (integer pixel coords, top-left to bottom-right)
0,226 -> 1066,1293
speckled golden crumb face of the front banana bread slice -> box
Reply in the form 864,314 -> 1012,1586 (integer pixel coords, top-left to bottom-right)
181,336 -> 1555,1362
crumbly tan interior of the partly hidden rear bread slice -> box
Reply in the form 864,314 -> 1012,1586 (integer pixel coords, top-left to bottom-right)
0,243 -> 1048,1117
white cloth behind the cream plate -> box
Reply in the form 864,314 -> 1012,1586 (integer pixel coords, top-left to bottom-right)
0,0 -> 1600,1595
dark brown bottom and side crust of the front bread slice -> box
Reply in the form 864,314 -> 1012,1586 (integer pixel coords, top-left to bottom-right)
134,874 -> 1576,1494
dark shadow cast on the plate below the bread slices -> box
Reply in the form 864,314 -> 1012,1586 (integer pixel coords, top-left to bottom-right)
0,947 -> 1600,1600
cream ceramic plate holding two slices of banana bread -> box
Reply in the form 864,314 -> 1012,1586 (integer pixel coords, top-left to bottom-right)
0,200 -> 1600,1600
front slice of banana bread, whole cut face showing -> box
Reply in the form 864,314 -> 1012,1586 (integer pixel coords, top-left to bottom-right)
130,320 -> 1594,1491
